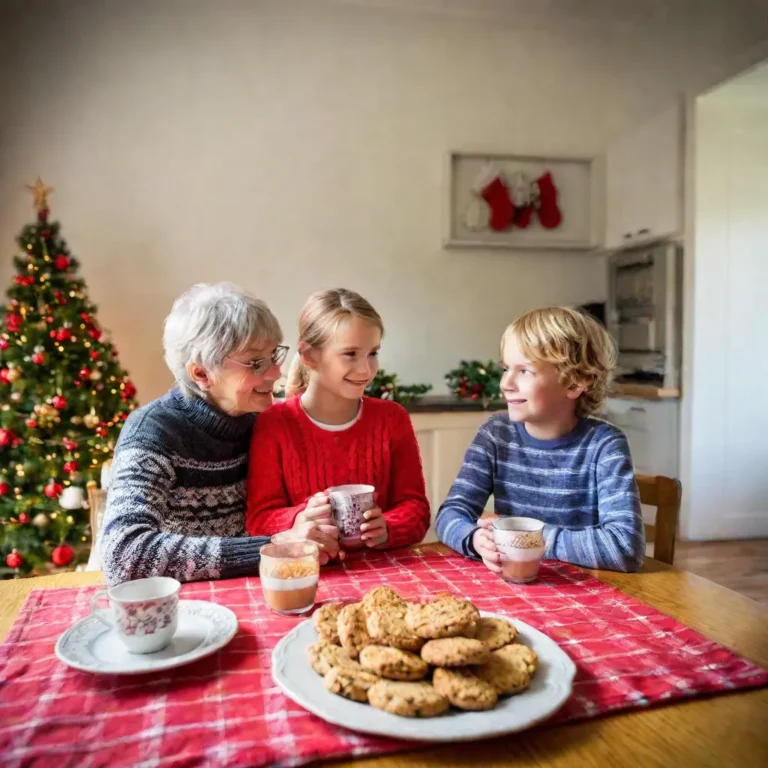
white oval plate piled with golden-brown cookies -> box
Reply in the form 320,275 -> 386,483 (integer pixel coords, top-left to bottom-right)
272,587 -> 576,741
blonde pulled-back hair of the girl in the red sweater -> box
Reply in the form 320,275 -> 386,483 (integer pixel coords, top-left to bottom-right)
285,288 -> 384,397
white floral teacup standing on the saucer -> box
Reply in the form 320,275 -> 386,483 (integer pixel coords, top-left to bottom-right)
91,576 -> 181,653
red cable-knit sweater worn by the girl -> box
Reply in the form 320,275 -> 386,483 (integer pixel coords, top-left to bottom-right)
246,396 -> 429,548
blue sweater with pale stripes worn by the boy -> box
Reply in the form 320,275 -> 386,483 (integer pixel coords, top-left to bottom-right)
435,413 -> 645,571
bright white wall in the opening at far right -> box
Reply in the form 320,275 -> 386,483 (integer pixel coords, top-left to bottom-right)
682,73 -> 768,540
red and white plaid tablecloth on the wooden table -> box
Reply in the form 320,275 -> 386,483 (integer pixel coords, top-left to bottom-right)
0,550 -> 768,768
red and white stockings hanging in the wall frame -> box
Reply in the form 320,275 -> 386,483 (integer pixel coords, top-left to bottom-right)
464,162 -> 563,232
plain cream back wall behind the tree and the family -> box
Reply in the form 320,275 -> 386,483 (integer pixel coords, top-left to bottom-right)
0,0 -> 764,402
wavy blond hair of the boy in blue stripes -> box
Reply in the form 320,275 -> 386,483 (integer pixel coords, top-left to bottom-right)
501,307 -> 616,416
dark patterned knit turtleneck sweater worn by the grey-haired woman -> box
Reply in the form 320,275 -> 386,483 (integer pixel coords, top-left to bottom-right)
101,389 -> 266,584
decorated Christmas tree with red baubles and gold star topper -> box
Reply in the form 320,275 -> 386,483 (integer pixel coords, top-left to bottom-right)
0,179 -> 136,576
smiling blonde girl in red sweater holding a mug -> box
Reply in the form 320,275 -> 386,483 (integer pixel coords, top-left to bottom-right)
246,289 -> 429,548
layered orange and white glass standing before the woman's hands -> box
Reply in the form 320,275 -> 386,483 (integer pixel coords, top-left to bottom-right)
259,541 -> 320,616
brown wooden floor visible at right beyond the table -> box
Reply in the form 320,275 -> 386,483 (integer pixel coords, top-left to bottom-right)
648,539 -> 768,605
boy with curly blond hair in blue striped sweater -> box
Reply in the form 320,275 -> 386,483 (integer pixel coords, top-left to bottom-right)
436,307 -> 645,573
